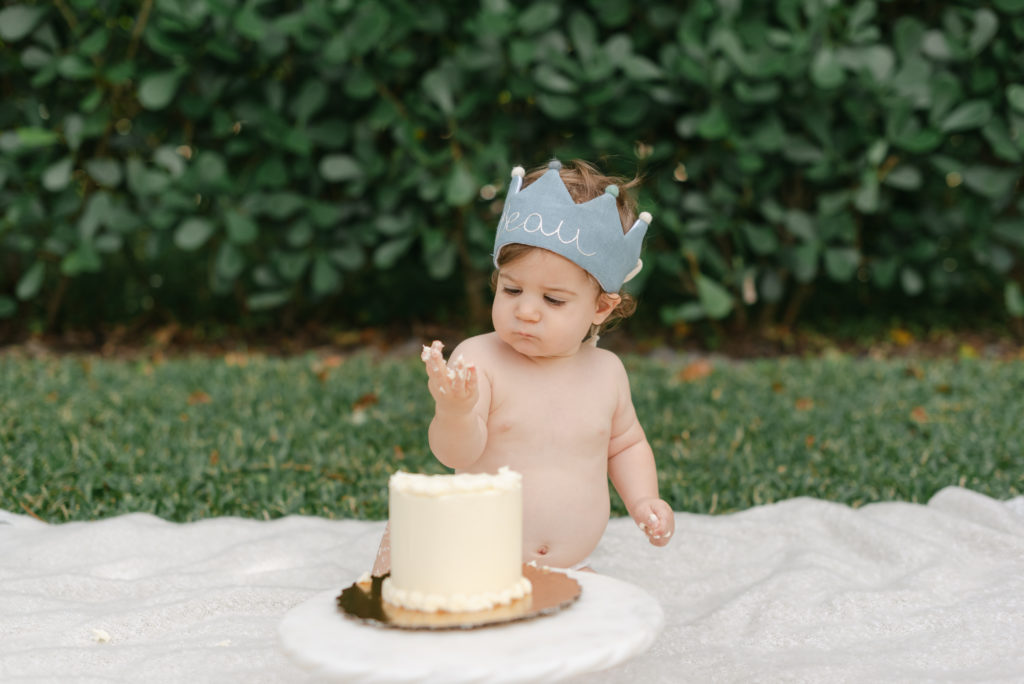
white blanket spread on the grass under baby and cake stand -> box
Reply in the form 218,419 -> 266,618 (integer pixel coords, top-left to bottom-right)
0,487 -> 1024,684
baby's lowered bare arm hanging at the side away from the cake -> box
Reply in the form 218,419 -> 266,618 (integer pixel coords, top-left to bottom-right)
608,362 -> 676,546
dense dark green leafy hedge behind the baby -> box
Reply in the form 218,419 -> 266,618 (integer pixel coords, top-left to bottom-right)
0,0 -> 1024,329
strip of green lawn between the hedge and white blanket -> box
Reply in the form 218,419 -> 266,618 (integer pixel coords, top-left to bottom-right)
0,355 -> 1024,522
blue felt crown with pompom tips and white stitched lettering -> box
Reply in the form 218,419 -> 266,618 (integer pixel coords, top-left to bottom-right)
494,160 -> 651,292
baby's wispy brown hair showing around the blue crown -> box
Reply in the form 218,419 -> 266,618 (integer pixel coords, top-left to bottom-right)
490,159 -> 640,338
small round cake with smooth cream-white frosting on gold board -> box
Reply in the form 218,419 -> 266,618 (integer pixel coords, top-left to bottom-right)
381,468 -> 531,612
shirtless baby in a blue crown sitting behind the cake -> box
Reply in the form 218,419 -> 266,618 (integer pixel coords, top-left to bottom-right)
374,162 -> 675,574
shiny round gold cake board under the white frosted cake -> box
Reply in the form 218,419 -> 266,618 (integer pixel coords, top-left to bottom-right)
337,565 -> 582,630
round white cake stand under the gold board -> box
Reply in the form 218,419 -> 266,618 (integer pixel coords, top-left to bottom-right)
278,572 -> 665,684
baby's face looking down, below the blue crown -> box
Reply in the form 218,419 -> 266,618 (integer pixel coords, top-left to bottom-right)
490,248 -> 614,357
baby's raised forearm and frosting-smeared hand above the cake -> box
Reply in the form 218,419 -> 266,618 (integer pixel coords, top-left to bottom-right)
422,341 -> 490,470
